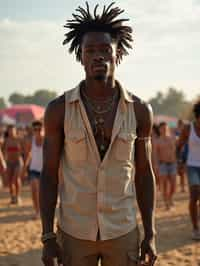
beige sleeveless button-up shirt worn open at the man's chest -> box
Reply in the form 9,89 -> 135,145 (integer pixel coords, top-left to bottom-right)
58,81 -> 137,241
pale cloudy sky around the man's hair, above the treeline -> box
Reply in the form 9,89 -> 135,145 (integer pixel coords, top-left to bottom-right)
0,0 -> 200,100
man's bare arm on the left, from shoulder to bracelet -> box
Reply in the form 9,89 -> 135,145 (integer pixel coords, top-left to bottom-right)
40,96 -> 64,234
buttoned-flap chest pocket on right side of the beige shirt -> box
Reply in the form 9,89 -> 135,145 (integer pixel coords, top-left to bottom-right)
115,132 -> 136,161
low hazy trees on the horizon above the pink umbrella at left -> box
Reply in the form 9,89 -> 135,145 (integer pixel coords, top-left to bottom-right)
9,89 -> 57,106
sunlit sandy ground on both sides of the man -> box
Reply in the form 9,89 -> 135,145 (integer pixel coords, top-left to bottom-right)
0,187 -> 200,266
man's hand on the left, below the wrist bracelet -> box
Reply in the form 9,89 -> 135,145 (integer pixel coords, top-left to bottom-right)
42,239 -> 63,266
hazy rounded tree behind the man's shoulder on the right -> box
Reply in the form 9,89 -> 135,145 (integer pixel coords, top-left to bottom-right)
149,87 -> 188,117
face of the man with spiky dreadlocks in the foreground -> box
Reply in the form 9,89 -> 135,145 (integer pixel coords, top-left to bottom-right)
81,32 -> 117,81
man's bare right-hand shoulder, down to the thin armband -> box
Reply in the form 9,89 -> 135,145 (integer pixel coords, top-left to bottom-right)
132,95 -> 153,135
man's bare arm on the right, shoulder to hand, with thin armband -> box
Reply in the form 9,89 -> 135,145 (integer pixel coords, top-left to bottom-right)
135,101 -> 156,265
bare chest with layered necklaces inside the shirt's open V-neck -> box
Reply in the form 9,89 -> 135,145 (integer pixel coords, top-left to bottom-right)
82,87 -> 118,159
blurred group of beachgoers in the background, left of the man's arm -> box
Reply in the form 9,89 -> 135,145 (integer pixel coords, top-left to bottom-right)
0,120 -> 44,218
